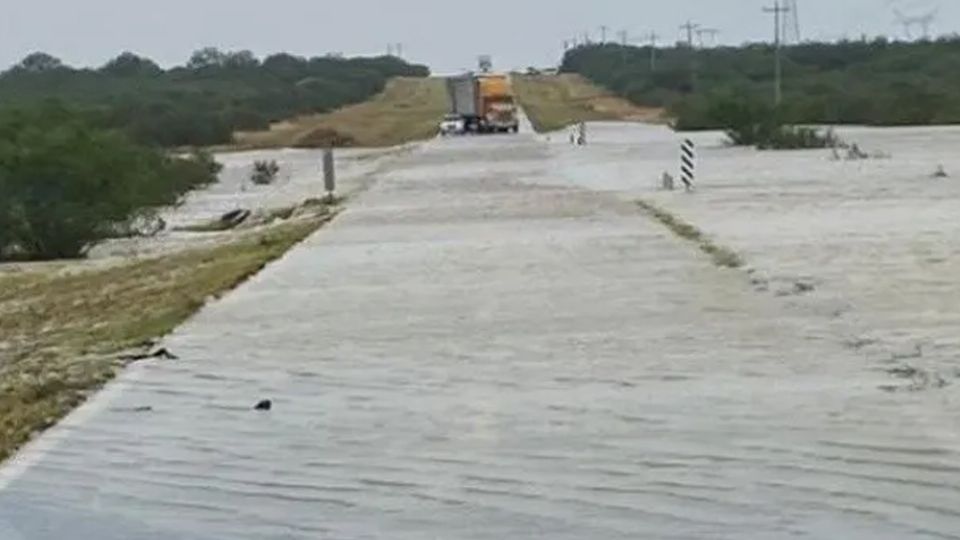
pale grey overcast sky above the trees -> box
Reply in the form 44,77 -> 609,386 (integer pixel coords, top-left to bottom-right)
0,0 -> 944,72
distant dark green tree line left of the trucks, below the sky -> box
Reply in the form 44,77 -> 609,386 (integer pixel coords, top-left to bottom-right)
0,48 -> 429,147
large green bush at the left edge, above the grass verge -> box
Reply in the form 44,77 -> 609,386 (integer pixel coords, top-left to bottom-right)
0,106 -> 219,259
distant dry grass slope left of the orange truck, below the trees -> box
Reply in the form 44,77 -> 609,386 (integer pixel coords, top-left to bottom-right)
234,78 -> 449,150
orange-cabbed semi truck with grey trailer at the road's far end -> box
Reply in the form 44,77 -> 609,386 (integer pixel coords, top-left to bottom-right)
447,73 -> 520,133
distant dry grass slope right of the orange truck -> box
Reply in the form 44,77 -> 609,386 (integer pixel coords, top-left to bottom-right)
513,74 -> 663,132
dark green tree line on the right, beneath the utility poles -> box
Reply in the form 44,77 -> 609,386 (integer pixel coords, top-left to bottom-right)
561,36 -> 960,129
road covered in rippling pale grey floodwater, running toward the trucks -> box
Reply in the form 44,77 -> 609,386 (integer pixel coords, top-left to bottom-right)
0,125 -> 960,540
